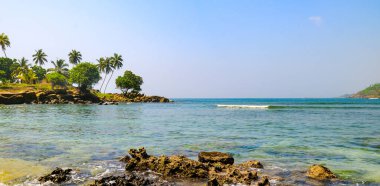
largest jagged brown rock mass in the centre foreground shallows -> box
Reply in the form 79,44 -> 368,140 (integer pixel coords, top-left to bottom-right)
117,148 -> 269,185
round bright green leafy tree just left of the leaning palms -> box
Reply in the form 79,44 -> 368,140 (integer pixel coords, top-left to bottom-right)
69,62 -> 100,90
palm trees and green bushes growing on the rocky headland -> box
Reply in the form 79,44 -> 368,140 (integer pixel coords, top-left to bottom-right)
0,33 -> 143,93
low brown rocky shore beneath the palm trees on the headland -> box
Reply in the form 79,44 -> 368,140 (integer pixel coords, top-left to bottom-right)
0,89 -> 170,105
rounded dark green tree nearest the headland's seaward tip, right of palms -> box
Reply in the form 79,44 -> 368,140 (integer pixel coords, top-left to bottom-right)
116,70 -> 144,94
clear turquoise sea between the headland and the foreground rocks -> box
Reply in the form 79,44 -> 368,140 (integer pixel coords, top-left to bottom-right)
0,99 -> 380,183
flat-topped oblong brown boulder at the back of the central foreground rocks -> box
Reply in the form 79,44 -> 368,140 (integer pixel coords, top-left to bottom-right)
198,152 -> 234,165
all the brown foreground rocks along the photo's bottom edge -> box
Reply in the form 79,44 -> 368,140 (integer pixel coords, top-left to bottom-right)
39,148 -> 347,186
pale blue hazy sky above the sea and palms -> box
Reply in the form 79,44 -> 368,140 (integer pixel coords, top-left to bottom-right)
0,0 -> 380,98
